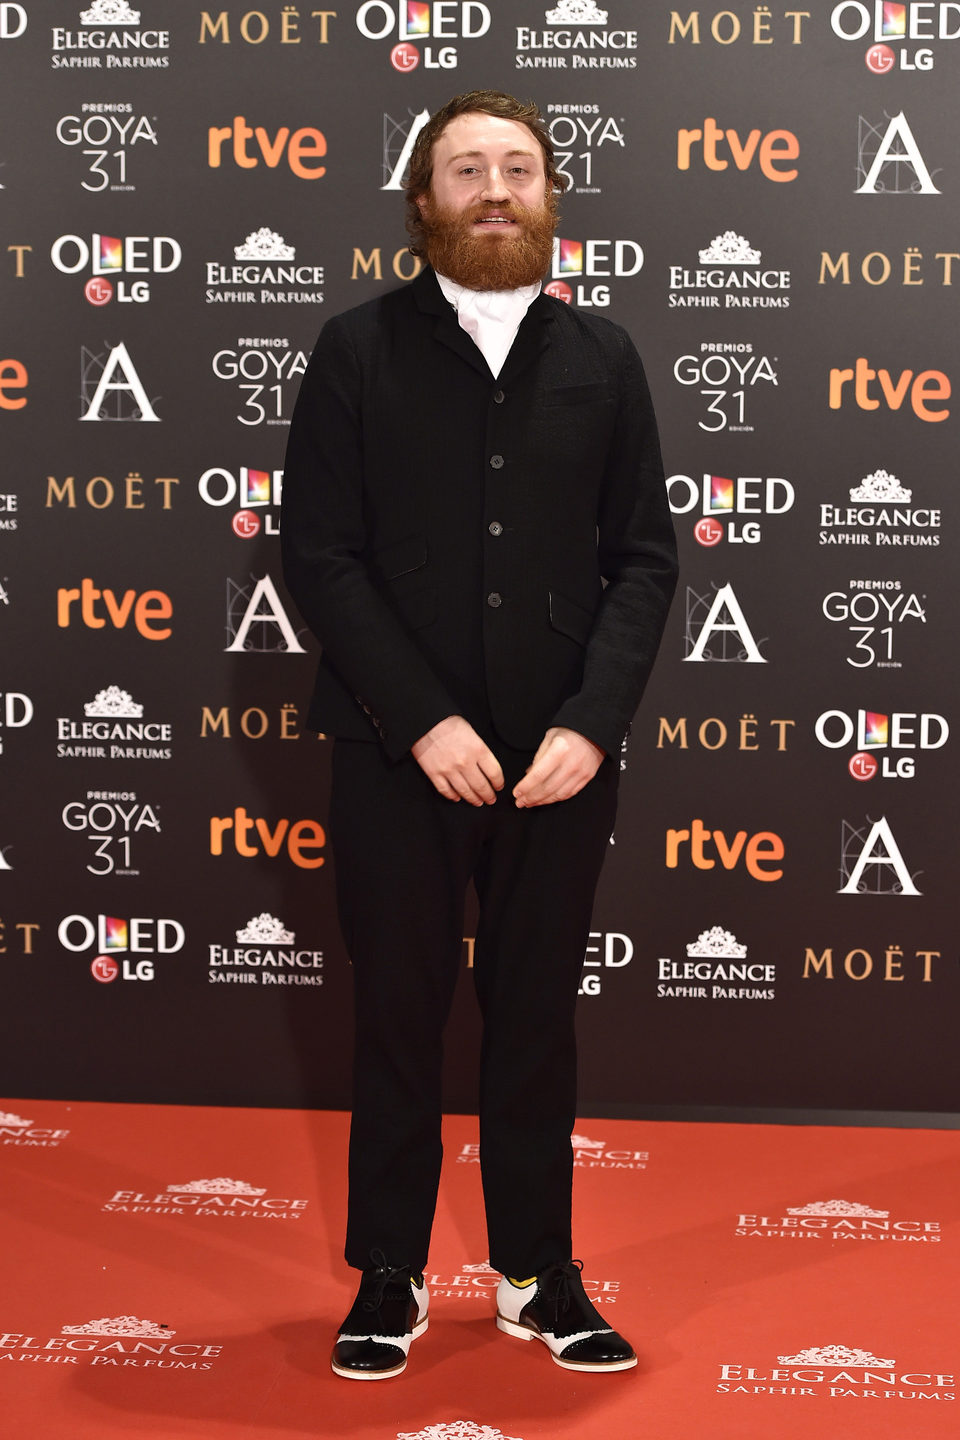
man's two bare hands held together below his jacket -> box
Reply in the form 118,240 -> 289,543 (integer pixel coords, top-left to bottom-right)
410,716 -> 604,809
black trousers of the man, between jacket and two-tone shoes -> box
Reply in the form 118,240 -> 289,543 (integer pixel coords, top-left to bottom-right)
330,740 -> 619,1277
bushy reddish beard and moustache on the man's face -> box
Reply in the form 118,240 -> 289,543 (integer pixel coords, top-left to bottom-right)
422,190 -> 557,289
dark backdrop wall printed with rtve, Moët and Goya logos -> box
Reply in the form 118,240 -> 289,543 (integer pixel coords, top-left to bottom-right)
0,0 -> 960,1115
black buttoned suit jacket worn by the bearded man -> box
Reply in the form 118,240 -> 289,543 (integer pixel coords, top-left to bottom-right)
281,269 -> 676,759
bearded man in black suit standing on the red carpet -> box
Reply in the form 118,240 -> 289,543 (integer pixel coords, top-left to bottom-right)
281,91 -> 675,1380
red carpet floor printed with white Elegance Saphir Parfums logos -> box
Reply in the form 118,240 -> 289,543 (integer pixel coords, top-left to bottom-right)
0,1100 -> 960,1440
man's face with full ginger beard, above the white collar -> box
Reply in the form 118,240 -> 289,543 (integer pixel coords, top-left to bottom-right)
417,112 -> 556,289
